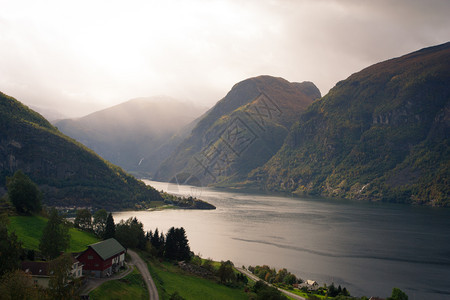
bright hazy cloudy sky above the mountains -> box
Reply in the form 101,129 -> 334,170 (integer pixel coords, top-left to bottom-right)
0,0 -> 450,116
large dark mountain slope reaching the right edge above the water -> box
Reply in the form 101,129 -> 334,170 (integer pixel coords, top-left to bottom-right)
249,43 -> 450,206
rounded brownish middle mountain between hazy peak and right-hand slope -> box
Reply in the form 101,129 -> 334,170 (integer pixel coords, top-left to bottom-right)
155,76 -> 320,185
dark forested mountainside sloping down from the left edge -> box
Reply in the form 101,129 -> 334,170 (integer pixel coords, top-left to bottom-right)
0,92 -> 162,210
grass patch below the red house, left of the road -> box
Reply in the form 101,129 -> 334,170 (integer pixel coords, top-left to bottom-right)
89,268 -> 148,300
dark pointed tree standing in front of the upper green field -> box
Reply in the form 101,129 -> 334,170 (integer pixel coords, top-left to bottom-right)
39,208 -> 70,259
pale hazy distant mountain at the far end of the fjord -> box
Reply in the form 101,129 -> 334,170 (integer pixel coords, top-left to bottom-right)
54,97 -> 205,177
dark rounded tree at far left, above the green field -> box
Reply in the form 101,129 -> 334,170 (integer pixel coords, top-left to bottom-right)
6,170 -> 42,214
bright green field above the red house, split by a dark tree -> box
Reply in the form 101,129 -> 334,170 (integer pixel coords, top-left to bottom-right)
8,216 -> 99,252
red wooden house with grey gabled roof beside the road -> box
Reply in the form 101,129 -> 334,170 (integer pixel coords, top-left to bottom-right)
77,238 -> 125,277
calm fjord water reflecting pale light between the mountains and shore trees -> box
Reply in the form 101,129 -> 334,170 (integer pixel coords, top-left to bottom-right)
114,181 -> 450,299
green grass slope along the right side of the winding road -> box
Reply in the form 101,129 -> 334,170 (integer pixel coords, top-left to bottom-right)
147,259 -> 248,300
